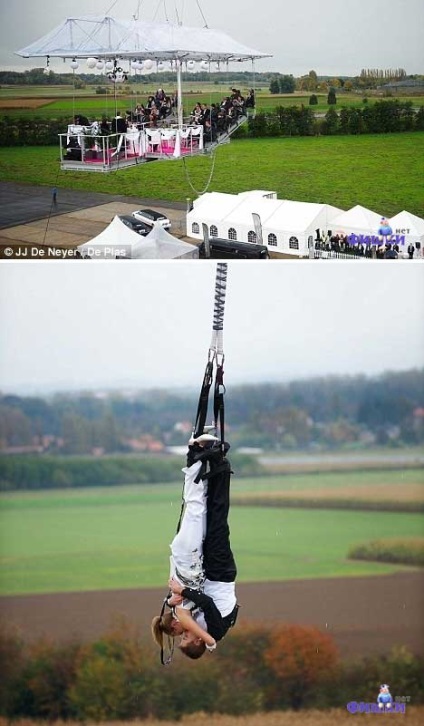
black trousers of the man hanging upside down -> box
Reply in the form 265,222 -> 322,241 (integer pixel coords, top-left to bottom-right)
203,459 -> 237,582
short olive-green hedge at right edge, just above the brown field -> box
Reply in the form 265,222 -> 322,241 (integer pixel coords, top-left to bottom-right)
348,537 -> 424,567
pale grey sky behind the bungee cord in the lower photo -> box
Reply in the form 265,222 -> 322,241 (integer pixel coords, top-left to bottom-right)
0,260 -> 424,392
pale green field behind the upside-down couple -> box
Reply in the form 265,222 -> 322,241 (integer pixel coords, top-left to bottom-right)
0,472 -> 424,595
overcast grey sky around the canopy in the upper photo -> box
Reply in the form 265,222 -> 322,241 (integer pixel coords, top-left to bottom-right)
0,0 -> 424,76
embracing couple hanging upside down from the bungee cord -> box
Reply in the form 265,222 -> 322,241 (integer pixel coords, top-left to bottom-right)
152,434 -> 238,659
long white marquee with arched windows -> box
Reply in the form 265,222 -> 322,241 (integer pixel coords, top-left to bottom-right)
187,190 -> 341,256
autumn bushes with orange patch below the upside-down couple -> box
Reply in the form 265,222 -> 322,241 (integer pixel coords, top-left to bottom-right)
0,622 -> 424,721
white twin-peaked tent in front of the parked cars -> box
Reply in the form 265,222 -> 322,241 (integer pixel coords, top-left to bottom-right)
78,216 -> 199,260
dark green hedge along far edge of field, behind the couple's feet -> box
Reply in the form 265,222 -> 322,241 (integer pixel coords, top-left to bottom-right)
0,454 -> 262,492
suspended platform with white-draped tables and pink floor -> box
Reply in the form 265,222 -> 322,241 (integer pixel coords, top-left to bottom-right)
59,115 -> 247,172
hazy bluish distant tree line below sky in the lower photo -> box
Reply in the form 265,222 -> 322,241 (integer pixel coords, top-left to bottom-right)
0,369 -> 424,455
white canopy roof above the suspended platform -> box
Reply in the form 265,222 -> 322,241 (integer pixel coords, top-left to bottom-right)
16,16 -> 270,61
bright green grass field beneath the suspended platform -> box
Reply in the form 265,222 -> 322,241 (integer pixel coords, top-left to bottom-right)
0,133 -> 424,217
